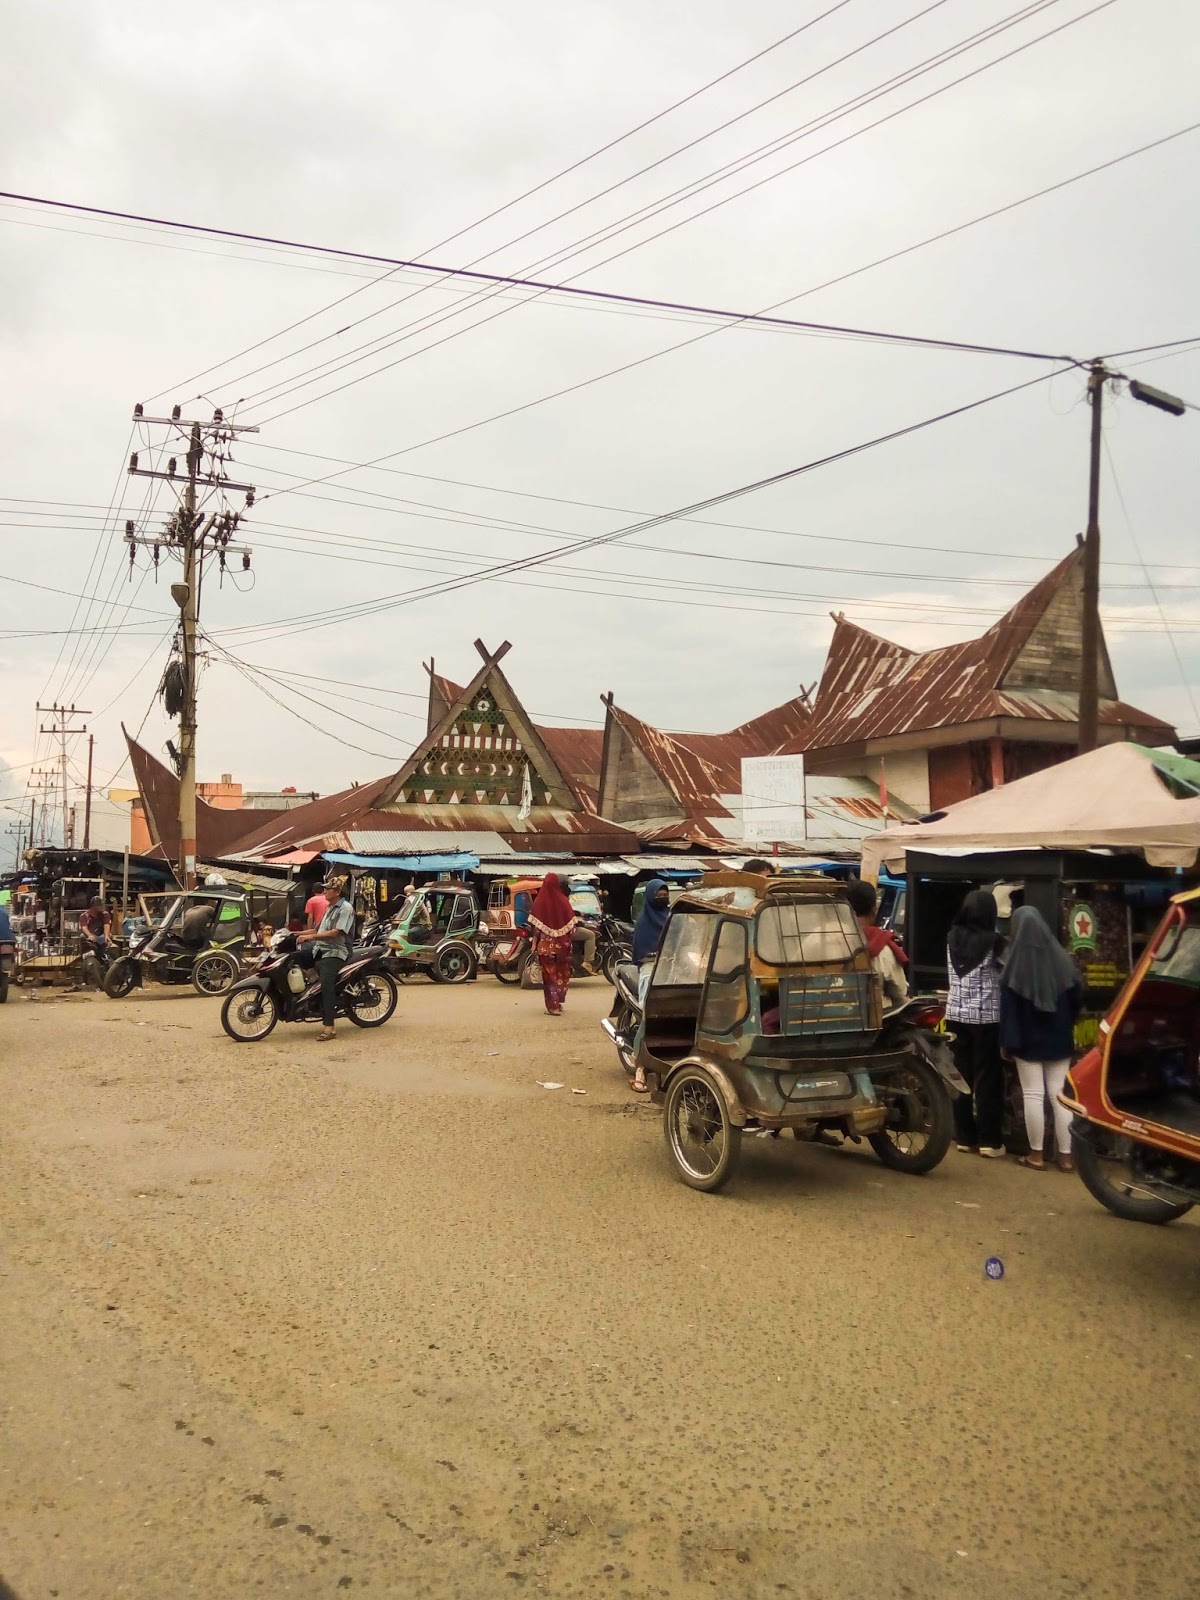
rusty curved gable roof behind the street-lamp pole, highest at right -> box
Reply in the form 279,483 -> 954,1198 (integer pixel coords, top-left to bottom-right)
781,547 -> 1174,754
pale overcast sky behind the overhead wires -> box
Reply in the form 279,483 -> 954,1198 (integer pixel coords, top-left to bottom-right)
0,0 -> 1200,838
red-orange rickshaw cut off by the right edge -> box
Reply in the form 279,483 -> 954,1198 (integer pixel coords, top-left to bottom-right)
1059,890 -> 1200,1222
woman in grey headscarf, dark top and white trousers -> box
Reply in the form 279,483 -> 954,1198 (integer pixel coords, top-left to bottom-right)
1000,906 -> 1080,1173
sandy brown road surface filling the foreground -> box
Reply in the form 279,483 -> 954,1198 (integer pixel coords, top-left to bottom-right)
0,981 -> 1200,1600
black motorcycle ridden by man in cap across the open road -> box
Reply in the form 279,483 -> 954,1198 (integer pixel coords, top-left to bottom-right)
221,931 -> 397,1045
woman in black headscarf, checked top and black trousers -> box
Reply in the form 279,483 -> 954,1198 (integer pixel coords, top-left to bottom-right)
946,890 -> 1005,1158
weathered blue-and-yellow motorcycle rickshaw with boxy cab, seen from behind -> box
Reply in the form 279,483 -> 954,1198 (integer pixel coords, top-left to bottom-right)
635,872 -> 952,1190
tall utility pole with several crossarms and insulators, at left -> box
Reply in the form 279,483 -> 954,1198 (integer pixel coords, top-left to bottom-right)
125,405 -> 258,890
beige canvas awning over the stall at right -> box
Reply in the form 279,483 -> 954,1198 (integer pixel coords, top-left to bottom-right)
862,744 -> 1200,880
